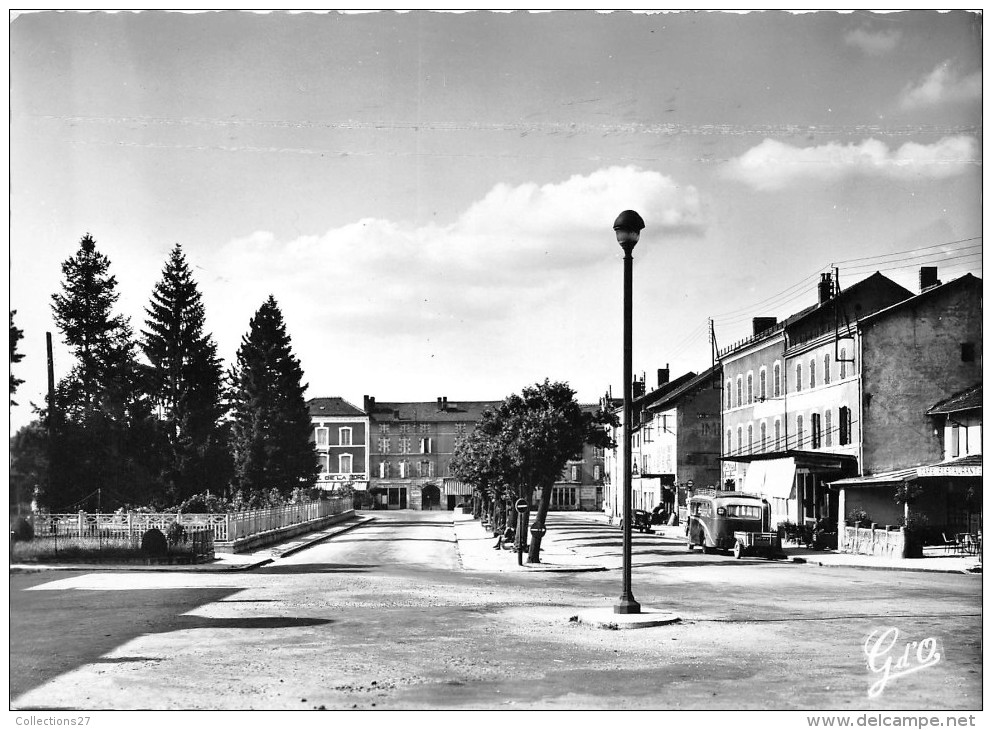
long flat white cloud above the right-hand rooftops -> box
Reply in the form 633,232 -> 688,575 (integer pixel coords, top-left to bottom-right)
723,135 -> 979,190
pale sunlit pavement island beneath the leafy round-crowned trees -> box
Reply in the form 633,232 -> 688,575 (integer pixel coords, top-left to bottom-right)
454,512 -> 606,573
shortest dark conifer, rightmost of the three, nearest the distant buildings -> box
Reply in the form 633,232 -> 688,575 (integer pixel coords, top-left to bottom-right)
231,296 -> 318,502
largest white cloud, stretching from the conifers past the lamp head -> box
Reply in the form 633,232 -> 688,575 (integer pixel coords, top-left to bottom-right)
204,167 -> 702,370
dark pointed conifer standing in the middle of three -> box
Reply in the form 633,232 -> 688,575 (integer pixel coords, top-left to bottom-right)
141,244 -> 230,503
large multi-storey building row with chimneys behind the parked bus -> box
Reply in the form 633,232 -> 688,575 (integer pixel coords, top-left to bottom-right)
720,267 -> 981,533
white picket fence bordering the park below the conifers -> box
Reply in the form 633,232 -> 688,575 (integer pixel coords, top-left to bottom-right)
29,498 -> 352,542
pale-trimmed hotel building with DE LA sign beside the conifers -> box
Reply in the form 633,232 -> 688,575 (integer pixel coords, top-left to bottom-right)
307,398 -> 369,491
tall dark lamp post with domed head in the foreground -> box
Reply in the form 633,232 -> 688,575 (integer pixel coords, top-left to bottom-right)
613,210 -> 644,613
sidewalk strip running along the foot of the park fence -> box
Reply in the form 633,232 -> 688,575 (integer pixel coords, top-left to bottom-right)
10,516 -> 375,573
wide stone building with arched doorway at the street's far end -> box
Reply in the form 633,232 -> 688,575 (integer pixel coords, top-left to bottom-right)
364,395 -> 502,510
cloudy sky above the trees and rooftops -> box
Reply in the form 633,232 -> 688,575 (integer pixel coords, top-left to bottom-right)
9,11 -> 982,430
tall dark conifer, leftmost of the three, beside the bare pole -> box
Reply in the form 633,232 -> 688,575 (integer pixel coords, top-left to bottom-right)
47,234 -> 154,509
